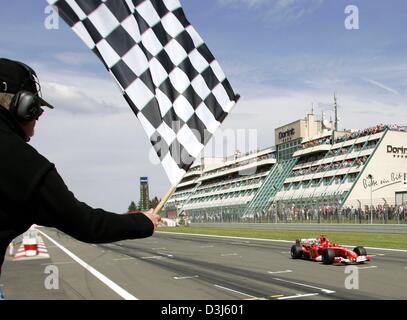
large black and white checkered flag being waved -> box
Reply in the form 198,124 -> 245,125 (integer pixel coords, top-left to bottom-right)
48,0 -> 236,186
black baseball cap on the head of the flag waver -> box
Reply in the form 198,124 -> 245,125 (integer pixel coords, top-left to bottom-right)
0,58 -> 54,109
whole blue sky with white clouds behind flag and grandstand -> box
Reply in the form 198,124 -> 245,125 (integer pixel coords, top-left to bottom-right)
0,0 -> 407,213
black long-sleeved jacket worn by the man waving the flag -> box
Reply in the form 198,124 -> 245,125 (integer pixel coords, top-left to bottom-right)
0,106 -> 154,268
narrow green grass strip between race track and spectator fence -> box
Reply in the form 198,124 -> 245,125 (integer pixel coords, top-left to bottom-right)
159,227 -> 407,249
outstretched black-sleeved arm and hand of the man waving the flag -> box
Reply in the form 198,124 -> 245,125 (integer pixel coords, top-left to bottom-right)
33,169 -> 159,243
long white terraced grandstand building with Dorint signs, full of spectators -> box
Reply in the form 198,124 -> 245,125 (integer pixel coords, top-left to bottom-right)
165,110 -> 407,221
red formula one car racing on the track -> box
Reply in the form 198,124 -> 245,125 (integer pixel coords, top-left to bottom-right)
291,235 -> 370,264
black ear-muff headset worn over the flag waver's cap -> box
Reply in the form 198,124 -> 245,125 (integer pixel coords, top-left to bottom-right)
10,61 -> 44,121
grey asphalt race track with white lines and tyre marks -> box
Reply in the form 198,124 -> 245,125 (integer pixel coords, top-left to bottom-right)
0,228 -> 407,300
